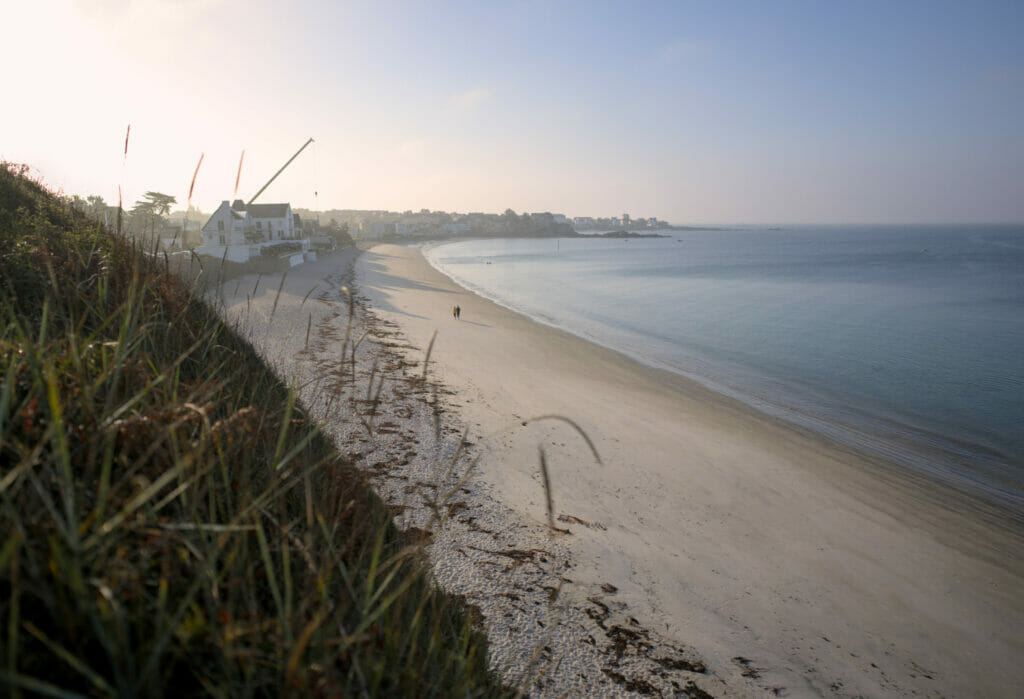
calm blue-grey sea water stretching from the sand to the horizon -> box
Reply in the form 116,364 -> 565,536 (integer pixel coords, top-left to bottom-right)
425,225 -> 1024,511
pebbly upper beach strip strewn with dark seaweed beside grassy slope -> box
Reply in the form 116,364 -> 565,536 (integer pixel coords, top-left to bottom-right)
215,250 -> 724,696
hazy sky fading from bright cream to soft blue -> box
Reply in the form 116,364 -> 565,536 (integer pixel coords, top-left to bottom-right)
0,0 -> 1024,223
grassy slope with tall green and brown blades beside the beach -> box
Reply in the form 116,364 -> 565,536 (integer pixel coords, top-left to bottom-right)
0,164 -> 509,697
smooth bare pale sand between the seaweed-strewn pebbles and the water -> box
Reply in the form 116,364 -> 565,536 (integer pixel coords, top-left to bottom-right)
359,246 -> 1024,696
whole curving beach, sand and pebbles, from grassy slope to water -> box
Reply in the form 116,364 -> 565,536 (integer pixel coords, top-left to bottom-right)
216,246 -> 1024,697
